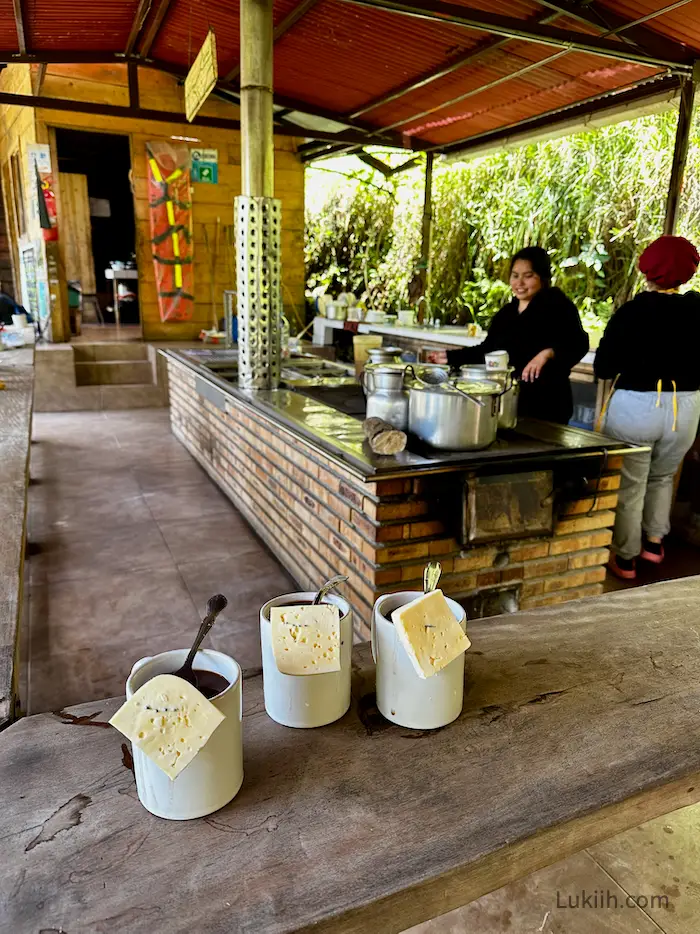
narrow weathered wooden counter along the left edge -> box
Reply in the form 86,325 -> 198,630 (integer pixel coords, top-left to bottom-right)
0,348 -> 34,730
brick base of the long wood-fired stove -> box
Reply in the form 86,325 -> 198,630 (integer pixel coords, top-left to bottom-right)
168,360 -> 622,638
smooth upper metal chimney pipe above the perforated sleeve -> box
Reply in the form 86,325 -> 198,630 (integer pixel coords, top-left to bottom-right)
241,0 -> 274,198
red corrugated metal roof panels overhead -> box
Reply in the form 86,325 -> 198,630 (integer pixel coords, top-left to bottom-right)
0,0 -> 700,146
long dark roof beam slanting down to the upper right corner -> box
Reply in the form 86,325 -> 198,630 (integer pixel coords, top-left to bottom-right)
345,0 -> 692,74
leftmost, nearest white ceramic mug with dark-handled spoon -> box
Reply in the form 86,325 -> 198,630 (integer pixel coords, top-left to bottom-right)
126,649 -> 243,820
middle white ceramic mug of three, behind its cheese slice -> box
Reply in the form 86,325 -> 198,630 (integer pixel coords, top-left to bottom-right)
260,591 -> 352,728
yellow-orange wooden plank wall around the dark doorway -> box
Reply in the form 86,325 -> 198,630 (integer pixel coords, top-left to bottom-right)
0,65 -> 304,340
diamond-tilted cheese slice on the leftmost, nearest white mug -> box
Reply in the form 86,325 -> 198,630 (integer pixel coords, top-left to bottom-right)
109,675 -> 225,779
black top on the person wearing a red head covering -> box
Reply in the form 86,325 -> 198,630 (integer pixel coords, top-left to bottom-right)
594,292 -> 700,392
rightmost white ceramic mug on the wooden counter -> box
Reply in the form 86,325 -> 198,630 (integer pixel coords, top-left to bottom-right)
372,590 -> 467,730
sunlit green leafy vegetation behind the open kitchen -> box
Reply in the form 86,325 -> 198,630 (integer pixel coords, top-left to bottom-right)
306,112 -> 700,342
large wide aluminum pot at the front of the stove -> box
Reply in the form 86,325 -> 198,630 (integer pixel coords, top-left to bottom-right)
408,381 -> 500,451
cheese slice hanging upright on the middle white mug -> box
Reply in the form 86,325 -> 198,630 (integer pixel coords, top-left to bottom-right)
270,603 -> 340,675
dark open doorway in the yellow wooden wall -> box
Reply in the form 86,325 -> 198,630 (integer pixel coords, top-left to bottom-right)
55,129 -> 140,336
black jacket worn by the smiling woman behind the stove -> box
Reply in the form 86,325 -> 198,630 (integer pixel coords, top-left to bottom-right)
447,287 -> 588,425
